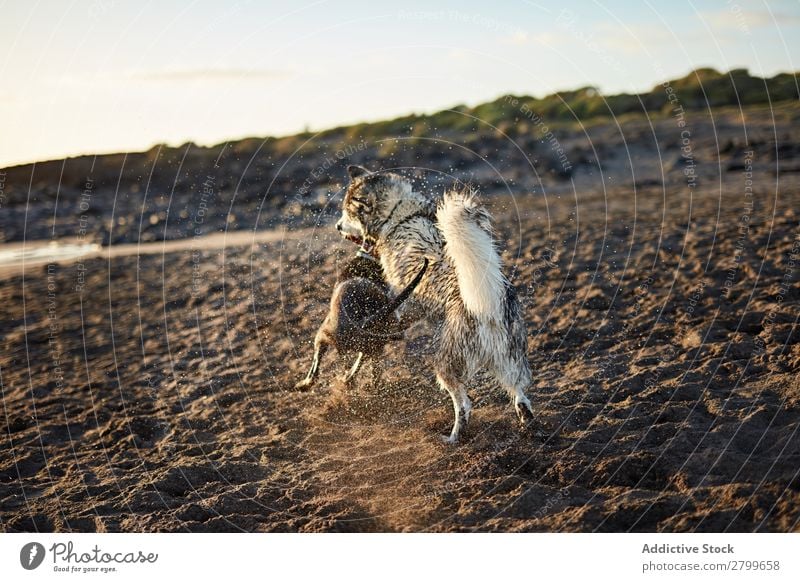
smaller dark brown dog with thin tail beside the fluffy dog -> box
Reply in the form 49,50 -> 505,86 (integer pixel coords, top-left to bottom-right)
295,250 -> 428,390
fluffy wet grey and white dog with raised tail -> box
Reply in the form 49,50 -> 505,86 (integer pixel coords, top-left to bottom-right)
336,166 -> 533,443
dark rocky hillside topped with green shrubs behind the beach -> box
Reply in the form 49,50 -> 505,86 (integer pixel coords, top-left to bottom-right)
0,69 -> 800,243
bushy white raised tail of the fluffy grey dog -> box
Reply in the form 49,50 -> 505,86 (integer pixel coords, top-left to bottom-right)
436,190 -> 505,319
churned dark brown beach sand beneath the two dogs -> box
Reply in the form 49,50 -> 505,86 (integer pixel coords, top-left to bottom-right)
0,170 -> 800,531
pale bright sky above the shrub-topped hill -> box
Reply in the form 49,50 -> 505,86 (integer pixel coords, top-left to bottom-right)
0,0 -> 800,167
